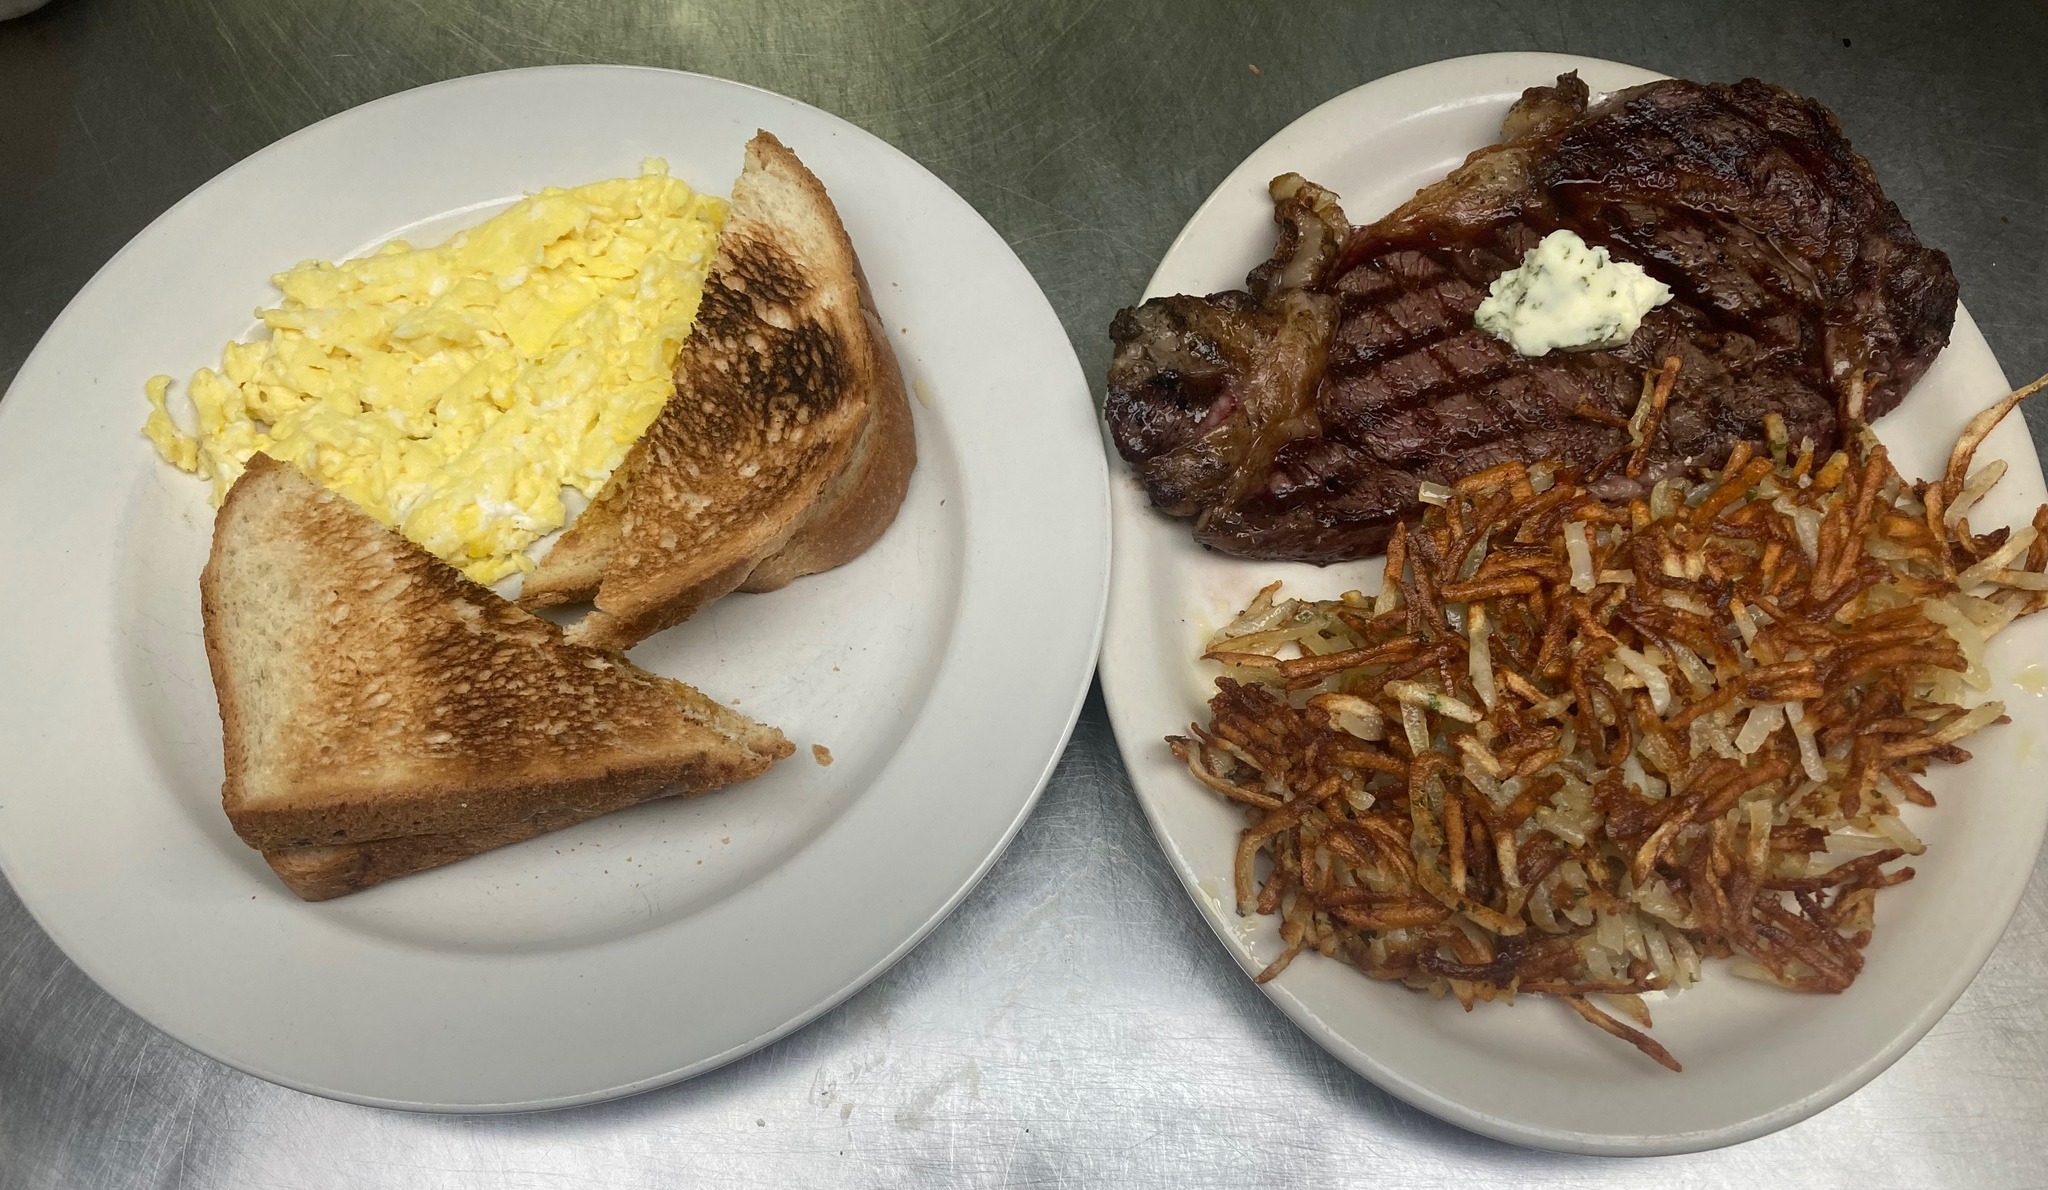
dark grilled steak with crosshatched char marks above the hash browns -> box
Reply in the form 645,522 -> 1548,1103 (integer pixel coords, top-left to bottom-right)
1106,76 -> 1956,563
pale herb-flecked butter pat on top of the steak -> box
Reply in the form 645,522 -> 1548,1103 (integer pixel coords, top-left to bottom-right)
1473,231 -> 1671,356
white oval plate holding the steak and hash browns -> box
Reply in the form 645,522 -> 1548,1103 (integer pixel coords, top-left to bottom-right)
1102,53 -> 2048,1153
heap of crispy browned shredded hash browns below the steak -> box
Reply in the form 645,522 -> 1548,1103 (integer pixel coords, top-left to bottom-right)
1167,370 -> 2048,1071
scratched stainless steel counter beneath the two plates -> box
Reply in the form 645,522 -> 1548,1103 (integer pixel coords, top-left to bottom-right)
0,0 -> 2048,1190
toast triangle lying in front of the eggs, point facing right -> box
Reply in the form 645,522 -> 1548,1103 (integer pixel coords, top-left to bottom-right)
199,457 -> 791,862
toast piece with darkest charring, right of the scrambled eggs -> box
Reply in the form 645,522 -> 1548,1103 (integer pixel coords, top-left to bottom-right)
520,133 -> 918,649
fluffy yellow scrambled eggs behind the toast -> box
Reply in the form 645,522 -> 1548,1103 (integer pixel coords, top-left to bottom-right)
143,160 -> 725,584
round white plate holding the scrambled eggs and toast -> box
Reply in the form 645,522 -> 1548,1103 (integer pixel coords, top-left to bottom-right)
0,68 -> 1108,1110
